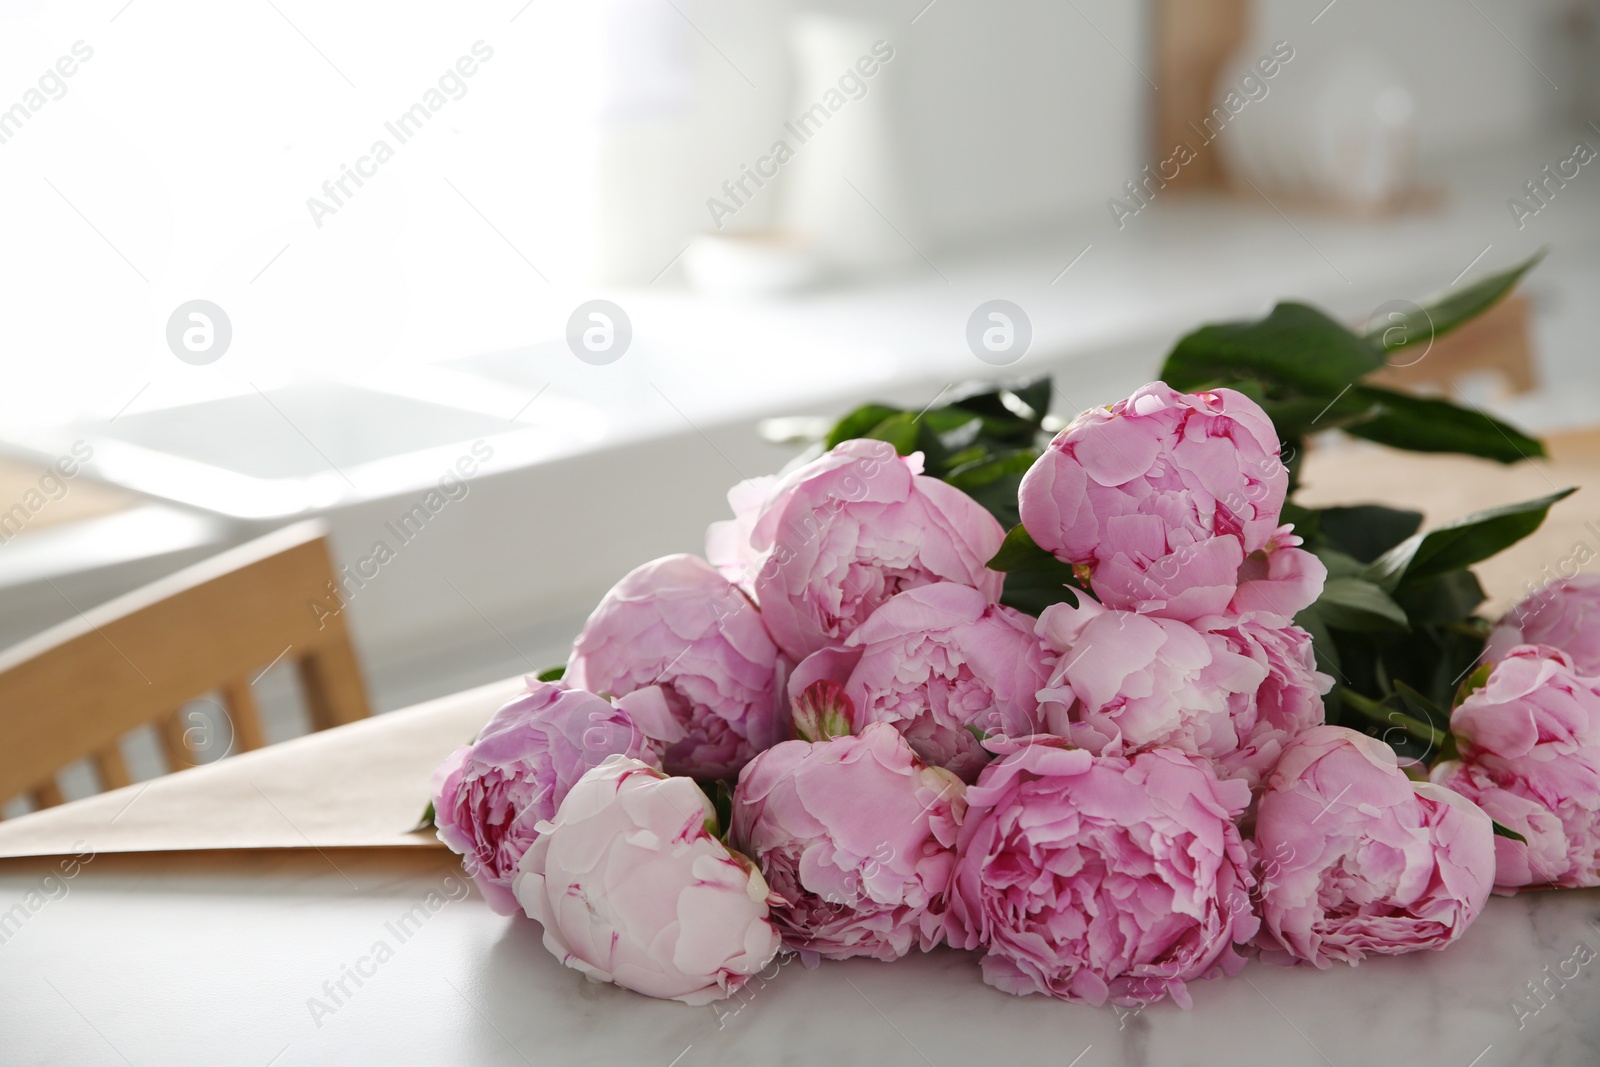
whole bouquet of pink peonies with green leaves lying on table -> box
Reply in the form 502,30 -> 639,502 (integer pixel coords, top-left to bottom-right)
432,254 -> 1600,1008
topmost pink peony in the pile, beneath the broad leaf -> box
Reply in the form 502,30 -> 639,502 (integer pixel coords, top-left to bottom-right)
1018,382 -> 1288,619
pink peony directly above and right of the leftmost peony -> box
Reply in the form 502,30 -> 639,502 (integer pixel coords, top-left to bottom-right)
565,555 -> 787,777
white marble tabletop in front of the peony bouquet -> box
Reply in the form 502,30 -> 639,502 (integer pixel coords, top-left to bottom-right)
0,825 -> 1600,1067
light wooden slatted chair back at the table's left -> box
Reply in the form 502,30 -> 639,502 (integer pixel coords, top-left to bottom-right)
0,522 -> 371,808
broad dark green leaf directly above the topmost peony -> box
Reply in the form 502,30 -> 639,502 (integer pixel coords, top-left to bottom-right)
1162,302 -> 1384,398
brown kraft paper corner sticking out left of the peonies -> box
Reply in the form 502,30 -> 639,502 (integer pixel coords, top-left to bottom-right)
0,678 -> 523,857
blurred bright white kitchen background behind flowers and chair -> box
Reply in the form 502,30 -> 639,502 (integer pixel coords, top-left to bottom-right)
0,0 -> 1600,799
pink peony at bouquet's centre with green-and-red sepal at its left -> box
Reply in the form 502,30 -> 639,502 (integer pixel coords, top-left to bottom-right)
790,582 -> 1050,782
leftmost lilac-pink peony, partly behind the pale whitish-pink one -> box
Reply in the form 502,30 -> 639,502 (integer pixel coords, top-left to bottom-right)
432,680 -> 658,915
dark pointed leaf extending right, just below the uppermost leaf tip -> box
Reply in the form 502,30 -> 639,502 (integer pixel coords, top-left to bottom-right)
1344,386 -> 1544,464
